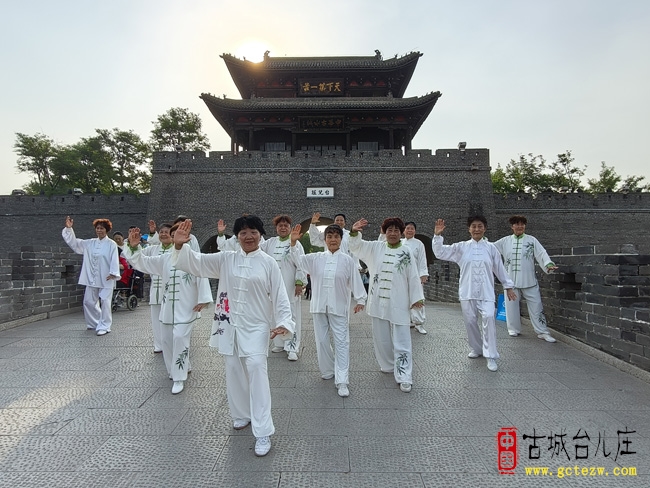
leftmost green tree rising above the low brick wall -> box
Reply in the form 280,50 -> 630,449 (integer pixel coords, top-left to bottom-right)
14,132 -> 67,194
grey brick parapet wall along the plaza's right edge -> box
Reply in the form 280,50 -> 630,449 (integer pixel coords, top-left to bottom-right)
536,245 -> 650,371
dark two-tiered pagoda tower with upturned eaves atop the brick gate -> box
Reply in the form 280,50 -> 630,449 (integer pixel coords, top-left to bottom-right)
201,51 -> 441,156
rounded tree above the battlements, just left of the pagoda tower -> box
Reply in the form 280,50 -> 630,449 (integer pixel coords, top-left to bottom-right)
150,108 -> 210,151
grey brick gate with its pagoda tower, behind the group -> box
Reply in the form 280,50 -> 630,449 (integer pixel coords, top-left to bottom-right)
148,51 -> 494,251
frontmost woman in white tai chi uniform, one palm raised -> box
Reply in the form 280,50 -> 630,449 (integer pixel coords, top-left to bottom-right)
172,215 -> 294,456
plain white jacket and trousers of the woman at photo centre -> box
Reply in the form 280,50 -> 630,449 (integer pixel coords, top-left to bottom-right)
291,248 -> 367,385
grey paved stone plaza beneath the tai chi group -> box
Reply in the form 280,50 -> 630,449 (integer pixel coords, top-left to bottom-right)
0,301 -> 650,488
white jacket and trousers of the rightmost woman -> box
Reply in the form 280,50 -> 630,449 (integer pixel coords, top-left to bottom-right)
494,233 -> 555,334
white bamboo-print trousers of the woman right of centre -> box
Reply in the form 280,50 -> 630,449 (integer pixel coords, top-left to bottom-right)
372,317 -> 413,384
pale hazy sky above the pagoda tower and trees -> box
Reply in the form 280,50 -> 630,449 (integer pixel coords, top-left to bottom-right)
0,0 -> 650,195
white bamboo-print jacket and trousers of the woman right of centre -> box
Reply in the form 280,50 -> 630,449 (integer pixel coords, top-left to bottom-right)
350,233 -> 424,384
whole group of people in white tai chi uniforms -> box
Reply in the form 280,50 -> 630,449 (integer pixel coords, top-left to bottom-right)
62,213 -> 557,456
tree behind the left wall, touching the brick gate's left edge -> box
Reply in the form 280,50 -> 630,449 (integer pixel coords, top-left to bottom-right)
96,128 -> 151,193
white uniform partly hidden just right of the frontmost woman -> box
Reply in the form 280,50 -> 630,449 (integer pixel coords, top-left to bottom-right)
260,236 -> 307,353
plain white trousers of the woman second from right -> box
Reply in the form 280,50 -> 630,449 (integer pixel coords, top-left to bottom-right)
460,300 -> 499,359
